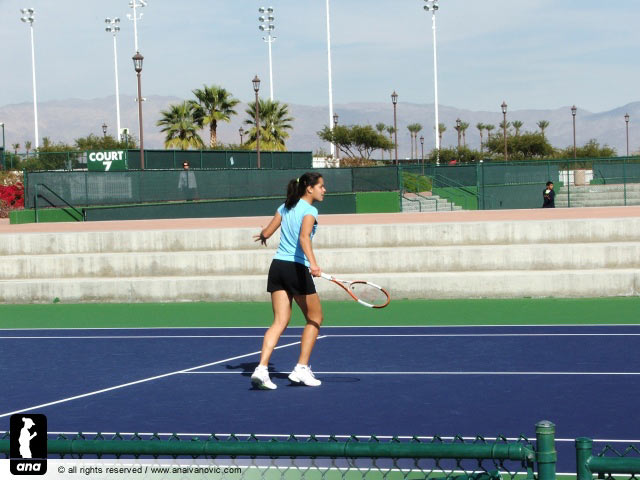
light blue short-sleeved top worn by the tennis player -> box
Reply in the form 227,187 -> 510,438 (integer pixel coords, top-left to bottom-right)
273,199 -> 318,267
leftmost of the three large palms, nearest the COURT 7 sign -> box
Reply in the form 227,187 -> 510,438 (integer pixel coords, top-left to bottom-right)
156,102 -> 204,150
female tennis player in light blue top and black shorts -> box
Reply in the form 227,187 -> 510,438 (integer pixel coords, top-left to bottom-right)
251,172 -> 326,390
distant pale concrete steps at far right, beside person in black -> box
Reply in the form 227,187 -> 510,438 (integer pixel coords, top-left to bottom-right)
555,183 -> 640,208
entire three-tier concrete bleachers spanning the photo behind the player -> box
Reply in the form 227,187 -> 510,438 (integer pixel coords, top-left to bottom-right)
0,218 -> 640,303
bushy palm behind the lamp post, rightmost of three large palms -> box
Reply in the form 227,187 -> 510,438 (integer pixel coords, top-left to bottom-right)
244,99 -> 294,152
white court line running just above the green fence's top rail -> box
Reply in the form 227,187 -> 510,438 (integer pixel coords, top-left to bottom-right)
0,430 -> 640,443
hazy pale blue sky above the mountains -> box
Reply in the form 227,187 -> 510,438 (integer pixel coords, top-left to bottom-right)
0,0 -> 640,111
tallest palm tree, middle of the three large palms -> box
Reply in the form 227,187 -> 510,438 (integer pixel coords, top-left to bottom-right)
191,85 -> 240,148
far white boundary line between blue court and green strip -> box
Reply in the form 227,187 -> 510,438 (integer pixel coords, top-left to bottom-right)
0,323 -> 640,332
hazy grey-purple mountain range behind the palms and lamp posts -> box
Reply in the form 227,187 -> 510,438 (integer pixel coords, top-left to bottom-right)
0,95 -> 640,157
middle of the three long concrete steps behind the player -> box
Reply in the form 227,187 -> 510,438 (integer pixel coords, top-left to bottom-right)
0,240 -> 640,281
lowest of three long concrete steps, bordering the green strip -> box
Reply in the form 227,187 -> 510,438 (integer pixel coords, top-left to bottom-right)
0,269 -> 640,303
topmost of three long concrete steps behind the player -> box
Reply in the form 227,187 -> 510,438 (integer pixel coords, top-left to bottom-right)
0,217 -> 640,256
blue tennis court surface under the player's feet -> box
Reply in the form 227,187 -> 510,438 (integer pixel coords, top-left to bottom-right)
0,325 -> 640,472
